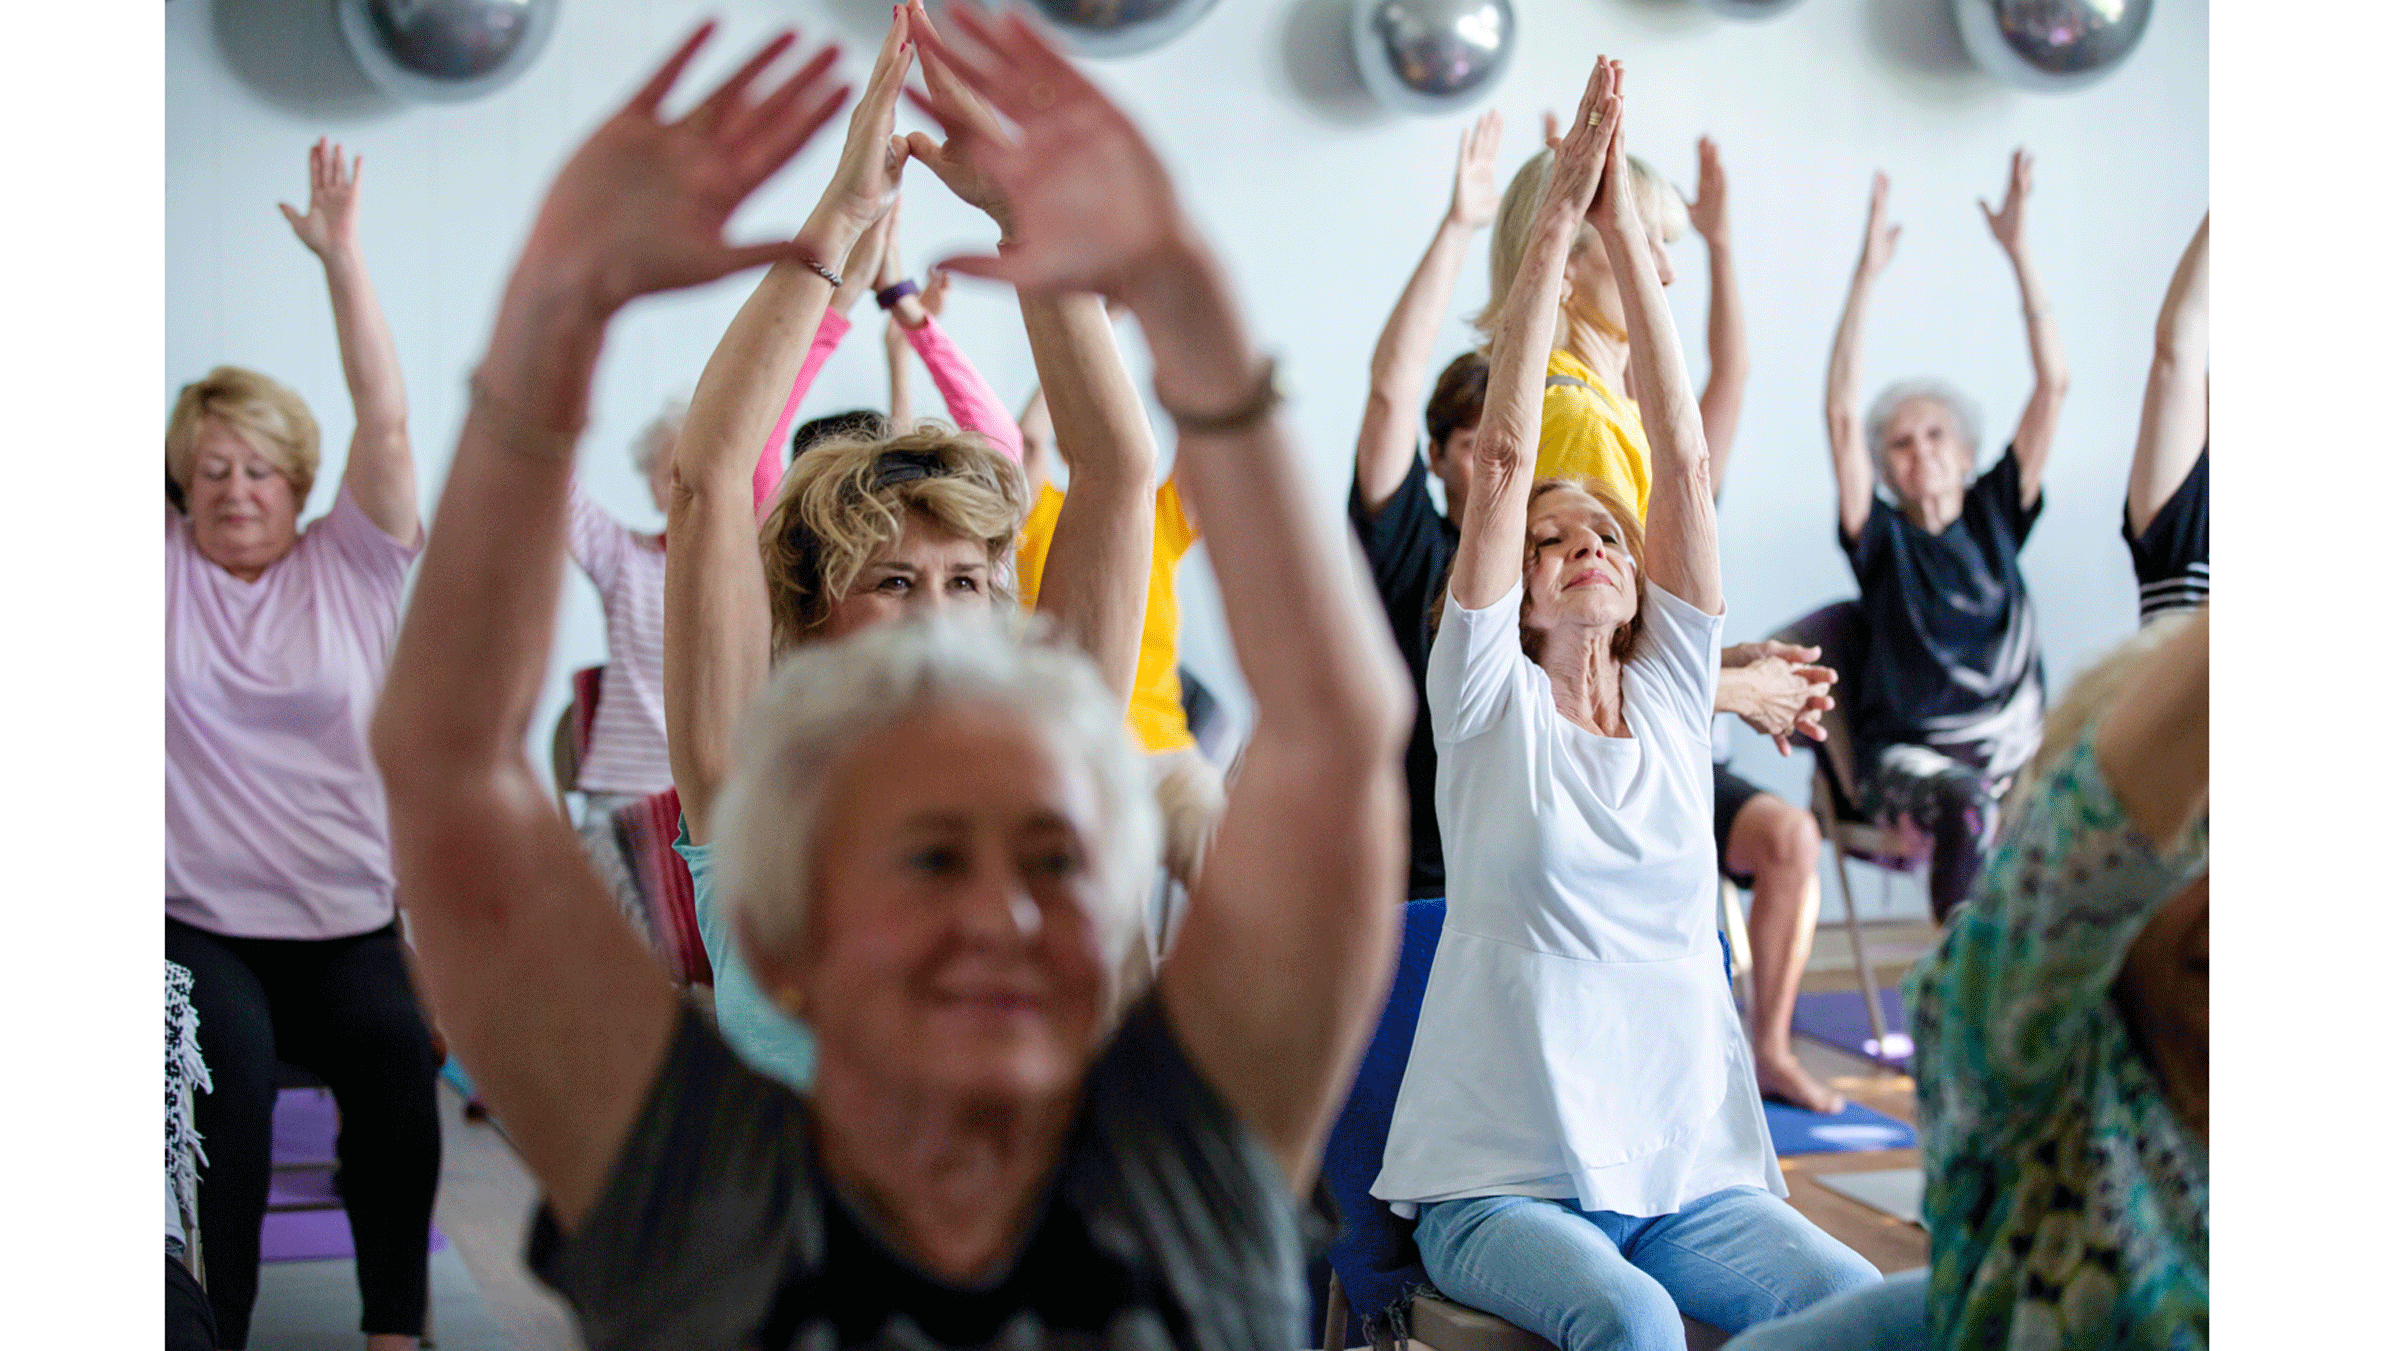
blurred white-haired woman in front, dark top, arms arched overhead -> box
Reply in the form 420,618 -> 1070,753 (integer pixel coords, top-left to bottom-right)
377,12 -> 1406,1351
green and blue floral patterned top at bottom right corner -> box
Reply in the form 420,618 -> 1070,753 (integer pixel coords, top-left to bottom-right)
1908,729 -> 2208,1351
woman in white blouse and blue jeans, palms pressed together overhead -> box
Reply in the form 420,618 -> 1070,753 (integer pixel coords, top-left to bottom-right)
1375,58 -> 1879,1351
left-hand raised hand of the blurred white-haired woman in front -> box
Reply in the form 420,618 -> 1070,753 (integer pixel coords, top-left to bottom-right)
518,24 -> 850,314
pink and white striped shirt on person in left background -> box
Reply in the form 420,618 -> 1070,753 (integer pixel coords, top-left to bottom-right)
566,482 -> 674,794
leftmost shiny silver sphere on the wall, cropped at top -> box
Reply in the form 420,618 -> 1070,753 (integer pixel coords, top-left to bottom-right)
336,0 -> 559,103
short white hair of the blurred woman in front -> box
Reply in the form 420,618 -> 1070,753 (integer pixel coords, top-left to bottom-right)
720,617 -> 1159,1003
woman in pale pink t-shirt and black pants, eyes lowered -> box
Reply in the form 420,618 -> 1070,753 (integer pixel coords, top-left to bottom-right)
166,142 -> 442,1351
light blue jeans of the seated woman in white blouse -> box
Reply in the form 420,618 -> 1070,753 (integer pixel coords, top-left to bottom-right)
1416,1188 -> 1884,1351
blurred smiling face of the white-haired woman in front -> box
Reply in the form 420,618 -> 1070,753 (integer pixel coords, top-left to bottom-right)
761,703 -> 1116,1099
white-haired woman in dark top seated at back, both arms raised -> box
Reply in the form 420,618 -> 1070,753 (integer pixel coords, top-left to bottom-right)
1824,151 -> 2066,919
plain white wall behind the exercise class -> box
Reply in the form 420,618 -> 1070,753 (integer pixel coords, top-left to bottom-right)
161,0 -> 2208,897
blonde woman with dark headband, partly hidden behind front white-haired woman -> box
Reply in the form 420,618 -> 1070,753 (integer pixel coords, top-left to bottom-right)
667,2 -> 1157,1089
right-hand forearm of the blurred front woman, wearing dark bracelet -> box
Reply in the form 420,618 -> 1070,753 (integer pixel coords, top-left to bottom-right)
1132,245 -> 1406,756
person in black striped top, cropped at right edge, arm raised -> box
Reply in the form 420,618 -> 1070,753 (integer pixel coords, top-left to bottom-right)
2124,216 -> 2208,624
